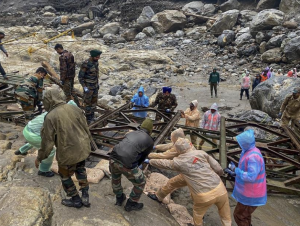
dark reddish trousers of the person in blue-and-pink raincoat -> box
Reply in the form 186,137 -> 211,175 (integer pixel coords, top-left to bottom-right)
233,202 -> 257,226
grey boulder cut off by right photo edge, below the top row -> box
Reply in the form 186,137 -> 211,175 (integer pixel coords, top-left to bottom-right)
283,36 -> 300,63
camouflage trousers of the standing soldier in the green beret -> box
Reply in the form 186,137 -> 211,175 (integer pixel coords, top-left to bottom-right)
84,88 -> 99,121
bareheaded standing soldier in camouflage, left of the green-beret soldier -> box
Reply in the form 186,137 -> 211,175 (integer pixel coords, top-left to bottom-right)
54,44 -> 79,104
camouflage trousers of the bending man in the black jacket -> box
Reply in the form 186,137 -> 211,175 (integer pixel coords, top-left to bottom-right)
109,160 -> 146,202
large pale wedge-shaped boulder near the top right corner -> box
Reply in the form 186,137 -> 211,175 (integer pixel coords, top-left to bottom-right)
250,9 -> 284,37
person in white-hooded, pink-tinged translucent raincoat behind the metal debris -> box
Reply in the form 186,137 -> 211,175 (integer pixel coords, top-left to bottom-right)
199,103 -> 221,149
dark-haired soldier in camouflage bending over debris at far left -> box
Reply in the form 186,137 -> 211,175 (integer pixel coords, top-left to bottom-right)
15,67 -> 48,119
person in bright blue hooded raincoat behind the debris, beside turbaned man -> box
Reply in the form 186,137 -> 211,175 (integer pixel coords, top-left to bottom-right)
131,86 -> 149,118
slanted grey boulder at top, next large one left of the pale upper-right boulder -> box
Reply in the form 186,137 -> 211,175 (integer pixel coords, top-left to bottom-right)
210,9 -> 240,34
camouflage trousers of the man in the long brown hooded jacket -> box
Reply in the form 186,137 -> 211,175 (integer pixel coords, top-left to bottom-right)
58,160 -> 89,197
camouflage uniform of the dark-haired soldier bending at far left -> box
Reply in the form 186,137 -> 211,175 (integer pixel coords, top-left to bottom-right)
15,76 -> 44,114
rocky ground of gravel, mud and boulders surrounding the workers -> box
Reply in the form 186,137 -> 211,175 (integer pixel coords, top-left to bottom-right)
0,0 -> 300,226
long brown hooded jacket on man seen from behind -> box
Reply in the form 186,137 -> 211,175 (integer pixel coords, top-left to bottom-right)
38,89 -> 91,165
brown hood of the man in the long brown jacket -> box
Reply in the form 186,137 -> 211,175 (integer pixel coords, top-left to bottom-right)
43,89 -> 65,112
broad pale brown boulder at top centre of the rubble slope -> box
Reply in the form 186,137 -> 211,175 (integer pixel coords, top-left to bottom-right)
151,10 -> 186,32
